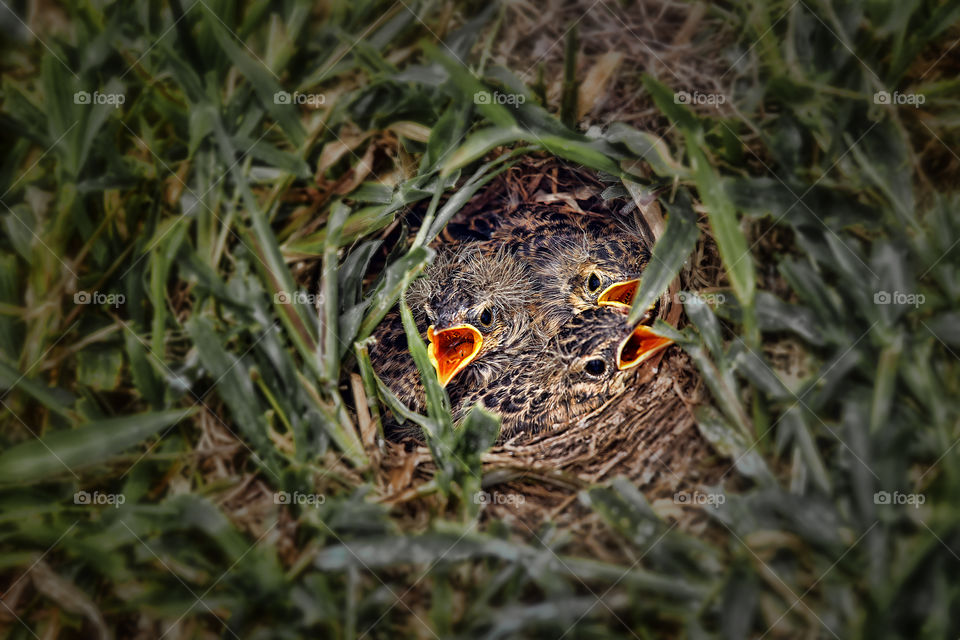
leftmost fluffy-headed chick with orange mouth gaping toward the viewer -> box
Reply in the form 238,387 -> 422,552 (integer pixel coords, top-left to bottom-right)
370,245 -> 534,411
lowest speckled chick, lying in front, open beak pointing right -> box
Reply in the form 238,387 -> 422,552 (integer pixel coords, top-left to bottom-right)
454,307 -> 672,437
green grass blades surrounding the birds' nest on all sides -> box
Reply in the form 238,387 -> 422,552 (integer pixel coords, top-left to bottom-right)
0,0 -> 960,638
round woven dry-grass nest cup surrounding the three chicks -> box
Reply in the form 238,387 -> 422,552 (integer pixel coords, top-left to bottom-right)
377,157 -> 727,531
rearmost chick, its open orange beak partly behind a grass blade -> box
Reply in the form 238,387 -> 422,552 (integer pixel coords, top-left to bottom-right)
489,204 -> 656,335
